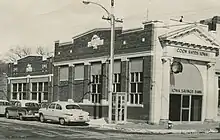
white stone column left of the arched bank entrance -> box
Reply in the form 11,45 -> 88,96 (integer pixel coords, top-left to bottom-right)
160,57 -> 172,124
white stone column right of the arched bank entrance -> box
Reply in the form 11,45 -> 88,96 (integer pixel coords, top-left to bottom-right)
203,63 -> 218,122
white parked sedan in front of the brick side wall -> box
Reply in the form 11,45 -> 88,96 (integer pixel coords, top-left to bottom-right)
39,101 -> 89,125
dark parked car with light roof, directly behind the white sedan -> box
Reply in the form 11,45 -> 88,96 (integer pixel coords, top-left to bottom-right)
5,100 -> 40,120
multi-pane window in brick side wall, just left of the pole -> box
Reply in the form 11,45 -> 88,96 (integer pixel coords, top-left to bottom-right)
91,75 -> 102,103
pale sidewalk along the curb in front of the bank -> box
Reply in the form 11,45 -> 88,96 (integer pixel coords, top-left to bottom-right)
89,119 -> 219,134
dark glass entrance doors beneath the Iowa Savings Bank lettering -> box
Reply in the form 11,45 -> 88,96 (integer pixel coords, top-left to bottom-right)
169,94 -> 202,121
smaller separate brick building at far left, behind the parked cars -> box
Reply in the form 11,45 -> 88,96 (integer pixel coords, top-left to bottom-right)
8,56 -> 53,102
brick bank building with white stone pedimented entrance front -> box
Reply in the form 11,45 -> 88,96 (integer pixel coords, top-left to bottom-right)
53,21 -> 220,124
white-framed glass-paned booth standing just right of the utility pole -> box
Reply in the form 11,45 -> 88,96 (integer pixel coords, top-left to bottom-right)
112,92 -> 127,123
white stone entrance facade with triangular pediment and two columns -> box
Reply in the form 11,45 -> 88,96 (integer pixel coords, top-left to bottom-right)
150,22 -> 219,123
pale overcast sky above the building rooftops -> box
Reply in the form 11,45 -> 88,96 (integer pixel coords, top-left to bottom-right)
0,0 -> 220,58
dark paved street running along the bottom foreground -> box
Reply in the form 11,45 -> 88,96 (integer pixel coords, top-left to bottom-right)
0,118 -> 220,140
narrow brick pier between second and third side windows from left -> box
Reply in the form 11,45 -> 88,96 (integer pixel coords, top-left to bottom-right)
83,62 -> 91,103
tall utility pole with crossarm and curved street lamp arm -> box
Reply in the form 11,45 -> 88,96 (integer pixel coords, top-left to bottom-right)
83,0 -> 122,123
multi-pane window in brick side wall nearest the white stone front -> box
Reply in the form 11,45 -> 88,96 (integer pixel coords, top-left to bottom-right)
130,72 -> 143,104
